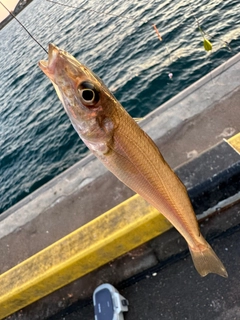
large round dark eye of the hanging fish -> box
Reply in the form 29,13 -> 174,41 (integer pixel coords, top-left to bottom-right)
78,81 -> 100,107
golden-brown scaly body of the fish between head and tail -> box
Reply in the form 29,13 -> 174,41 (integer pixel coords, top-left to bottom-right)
99,106 -> 199,243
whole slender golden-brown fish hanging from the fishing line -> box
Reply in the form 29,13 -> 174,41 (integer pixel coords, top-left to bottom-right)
39,44 -> 228,277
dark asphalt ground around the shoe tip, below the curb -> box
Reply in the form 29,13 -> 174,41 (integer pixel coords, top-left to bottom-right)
50,205 -> 240,320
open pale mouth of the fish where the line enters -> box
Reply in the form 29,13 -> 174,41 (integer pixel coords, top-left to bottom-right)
38,43 -> 60,80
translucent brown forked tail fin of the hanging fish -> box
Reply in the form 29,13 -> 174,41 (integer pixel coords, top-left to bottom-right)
189,236 -> 228,278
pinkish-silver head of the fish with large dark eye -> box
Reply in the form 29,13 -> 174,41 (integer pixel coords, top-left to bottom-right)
39,44 -> 117,143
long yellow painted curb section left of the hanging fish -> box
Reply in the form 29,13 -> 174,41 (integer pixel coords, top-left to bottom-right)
0,195 -> 171,319
